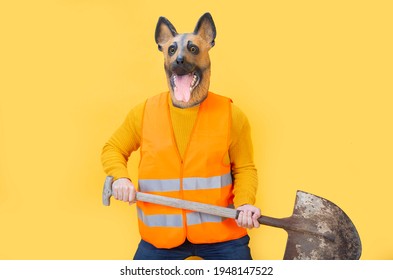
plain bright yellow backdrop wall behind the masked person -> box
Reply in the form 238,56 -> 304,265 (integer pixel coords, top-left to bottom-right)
0,0 -> 393,259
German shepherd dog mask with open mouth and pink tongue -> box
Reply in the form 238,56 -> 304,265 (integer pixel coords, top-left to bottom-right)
155,13 -> 216,108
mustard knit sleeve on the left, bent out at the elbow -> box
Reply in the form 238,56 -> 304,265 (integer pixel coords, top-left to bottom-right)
101,103 -> 145,180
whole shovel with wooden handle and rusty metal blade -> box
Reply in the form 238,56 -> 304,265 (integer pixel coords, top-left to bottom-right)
102,176 -> 362,260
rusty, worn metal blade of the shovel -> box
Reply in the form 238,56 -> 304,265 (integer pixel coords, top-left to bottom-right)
284,191 -> 362,260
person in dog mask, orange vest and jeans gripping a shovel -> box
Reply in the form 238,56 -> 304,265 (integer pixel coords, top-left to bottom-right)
102,13 -> 260,260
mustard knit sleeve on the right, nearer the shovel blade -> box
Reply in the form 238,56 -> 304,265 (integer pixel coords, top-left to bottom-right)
229,104 -> 258,208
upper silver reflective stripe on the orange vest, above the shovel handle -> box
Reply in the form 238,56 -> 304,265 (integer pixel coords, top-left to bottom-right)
138,173 -> 232,192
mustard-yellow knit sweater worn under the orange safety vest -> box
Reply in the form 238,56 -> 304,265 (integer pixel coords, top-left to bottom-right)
101,93 -> 258,207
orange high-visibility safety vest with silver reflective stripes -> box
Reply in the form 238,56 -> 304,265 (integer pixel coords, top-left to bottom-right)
137,92 -> 247,248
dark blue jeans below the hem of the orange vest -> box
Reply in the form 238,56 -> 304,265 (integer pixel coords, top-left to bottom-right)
134,235 -> 252,260
